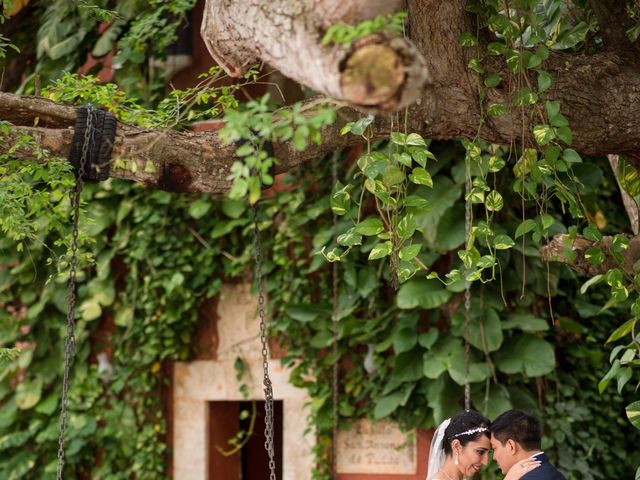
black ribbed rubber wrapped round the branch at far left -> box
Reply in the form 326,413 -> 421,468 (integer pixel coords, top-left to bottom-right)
69,107 -> 116,181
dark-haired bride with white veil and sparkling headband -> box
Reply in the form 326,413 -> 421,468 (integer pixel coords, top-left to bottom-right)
427,411 -> 540,480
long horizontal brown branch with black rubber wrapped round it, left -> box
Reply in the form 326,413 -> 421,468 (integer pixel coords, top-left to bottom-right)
0,92 -> 372,194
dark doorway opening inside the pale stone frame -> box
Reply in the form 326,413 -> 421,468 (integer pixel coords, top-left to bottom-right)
208,401 -> 282,480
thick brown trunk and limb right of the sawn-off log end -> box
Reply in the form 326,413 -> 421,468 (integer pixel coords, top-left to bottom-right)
408,0 -> 640,167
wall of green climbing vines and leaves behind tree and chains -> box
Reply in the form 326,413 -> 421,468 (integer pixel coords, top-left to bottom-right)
0,0 -> 640,480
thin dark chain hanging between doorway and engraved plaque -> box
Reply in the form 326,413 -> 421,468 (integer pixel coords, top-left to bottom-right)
331,154 -> 340,480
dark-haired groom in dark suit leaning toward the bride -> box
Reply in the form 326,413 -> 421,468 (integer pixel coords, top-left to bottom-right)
491,410 -> 566,480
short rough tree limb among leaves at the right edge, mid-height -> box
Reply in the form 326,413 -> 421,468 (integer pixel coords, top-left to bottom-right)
540,234 -> 640,277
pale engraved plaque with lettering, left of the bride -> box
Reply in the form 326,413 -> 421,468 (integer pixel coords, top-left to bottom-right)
336,419 -> 418,475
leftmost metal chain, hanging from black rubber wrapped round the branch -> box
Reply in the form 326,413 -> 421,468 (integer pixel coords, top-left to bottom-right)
56,106 -> 94,480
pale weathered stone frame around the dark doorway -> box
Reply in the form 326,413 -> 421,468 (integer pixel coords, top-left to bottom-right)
173,284 -> 315,480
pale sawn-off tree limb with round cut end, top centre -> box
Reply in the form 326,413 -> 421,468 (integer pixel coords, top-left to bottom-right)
201,0 -> 428,112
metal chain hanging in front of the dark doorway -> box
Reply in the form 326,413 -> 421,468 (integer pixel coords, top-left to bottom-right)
253,203 -> 276,480
